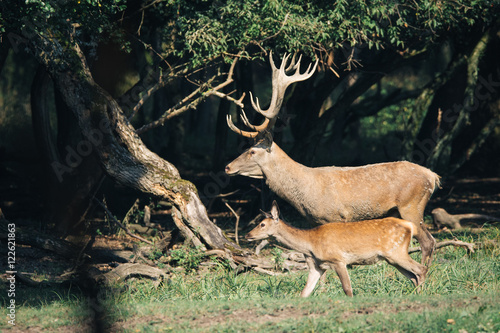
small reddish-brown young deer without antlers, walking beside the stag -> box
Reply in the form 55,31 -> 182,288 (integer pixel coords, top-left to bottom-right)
245,201 -> 427,297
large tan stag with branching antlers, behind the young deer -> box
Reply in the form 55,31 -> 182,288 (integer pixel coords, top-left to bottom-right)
226,51 -> 439,264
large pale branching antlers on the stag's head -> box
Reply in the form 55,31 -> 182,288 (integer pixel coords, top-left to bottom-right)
227,52 -> 319,138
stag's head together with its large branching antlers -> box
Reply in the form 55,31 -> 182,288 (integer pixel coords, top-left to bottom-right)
226,52 -> 318,178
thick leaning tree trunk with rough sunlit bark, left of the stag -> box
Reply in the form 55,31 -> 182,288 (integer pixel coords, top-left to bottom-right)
35,39 -> 239,250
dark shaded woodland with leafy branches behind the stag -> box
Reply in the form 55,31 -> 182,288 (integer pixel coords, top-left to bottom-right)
0,0 -> 500,242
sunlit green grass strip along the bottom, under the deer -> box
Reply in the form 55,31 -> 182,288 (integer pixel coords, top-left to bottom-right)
0,227 -> 500,333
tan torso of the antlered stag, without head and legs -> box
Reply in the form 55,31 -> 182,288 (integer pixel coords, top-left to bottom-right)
268,161 -> 439,224
